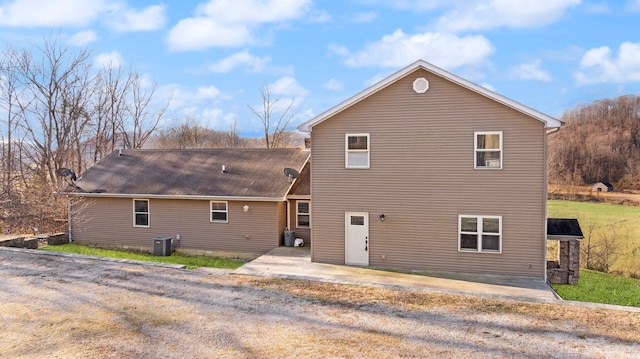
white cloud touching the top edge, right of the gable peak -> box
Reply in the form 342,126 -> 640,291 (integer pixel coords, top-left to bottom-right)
436,0 -> 581,32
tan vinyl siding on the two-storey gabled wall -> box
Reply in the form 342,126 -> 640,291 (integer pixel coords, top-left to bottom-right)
311,70 -> 546,277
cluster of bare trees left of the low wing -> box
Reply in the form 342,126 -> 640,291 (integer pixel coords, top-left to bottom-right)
0,38 -> 170,232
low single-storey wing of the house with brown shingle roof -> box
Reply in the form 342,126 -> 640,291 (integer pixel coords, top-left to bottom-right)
69,149 -> 310,257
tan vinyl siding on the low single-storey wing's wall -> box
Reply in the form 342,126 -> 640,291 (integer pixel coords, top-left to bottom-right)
72,198 -> 286,253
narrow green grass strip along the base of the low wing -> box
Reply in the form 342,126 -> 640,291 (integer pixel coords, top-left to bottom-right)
40,243 -> 244,269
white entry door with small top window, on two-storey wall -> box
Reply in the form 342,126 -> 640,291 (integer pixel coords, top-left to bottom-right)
344,212 -> 369,266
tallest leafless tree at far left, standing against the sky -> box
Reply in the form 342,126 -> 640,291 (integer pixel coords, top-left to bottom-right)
12,39 -> 91,188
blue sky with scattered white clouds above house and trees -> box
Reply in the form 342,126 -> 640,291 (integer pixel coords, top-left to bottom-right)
0,0 -> 640,136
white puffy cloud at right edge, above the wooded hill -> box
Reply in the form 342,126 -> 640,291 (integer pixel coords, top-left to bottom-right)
575,42 -> 640,84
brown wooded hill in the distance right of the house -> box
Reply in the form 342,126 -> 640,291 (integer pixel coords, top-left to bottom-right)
549,95 -> 640,189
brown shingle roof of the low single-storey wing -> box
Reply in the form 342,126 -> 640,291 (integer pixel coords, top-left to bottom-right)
74,148 -> 309,200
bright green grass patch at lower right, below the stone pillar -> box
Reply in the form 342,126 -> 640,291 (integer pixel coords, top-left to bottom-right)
551,269 -> 640,307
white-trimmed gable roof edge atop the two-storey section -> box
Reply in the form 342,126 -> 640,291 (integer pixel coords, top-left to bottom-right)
298,60 -> 564,132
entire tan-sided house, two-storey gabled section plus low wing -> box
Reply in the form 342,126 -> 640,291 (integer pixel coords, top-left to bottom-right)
70,61 -> 563,278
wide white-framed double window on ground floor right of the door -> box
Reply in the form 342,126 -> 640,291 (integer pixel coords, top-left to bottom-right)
458,215 -> 502,253
